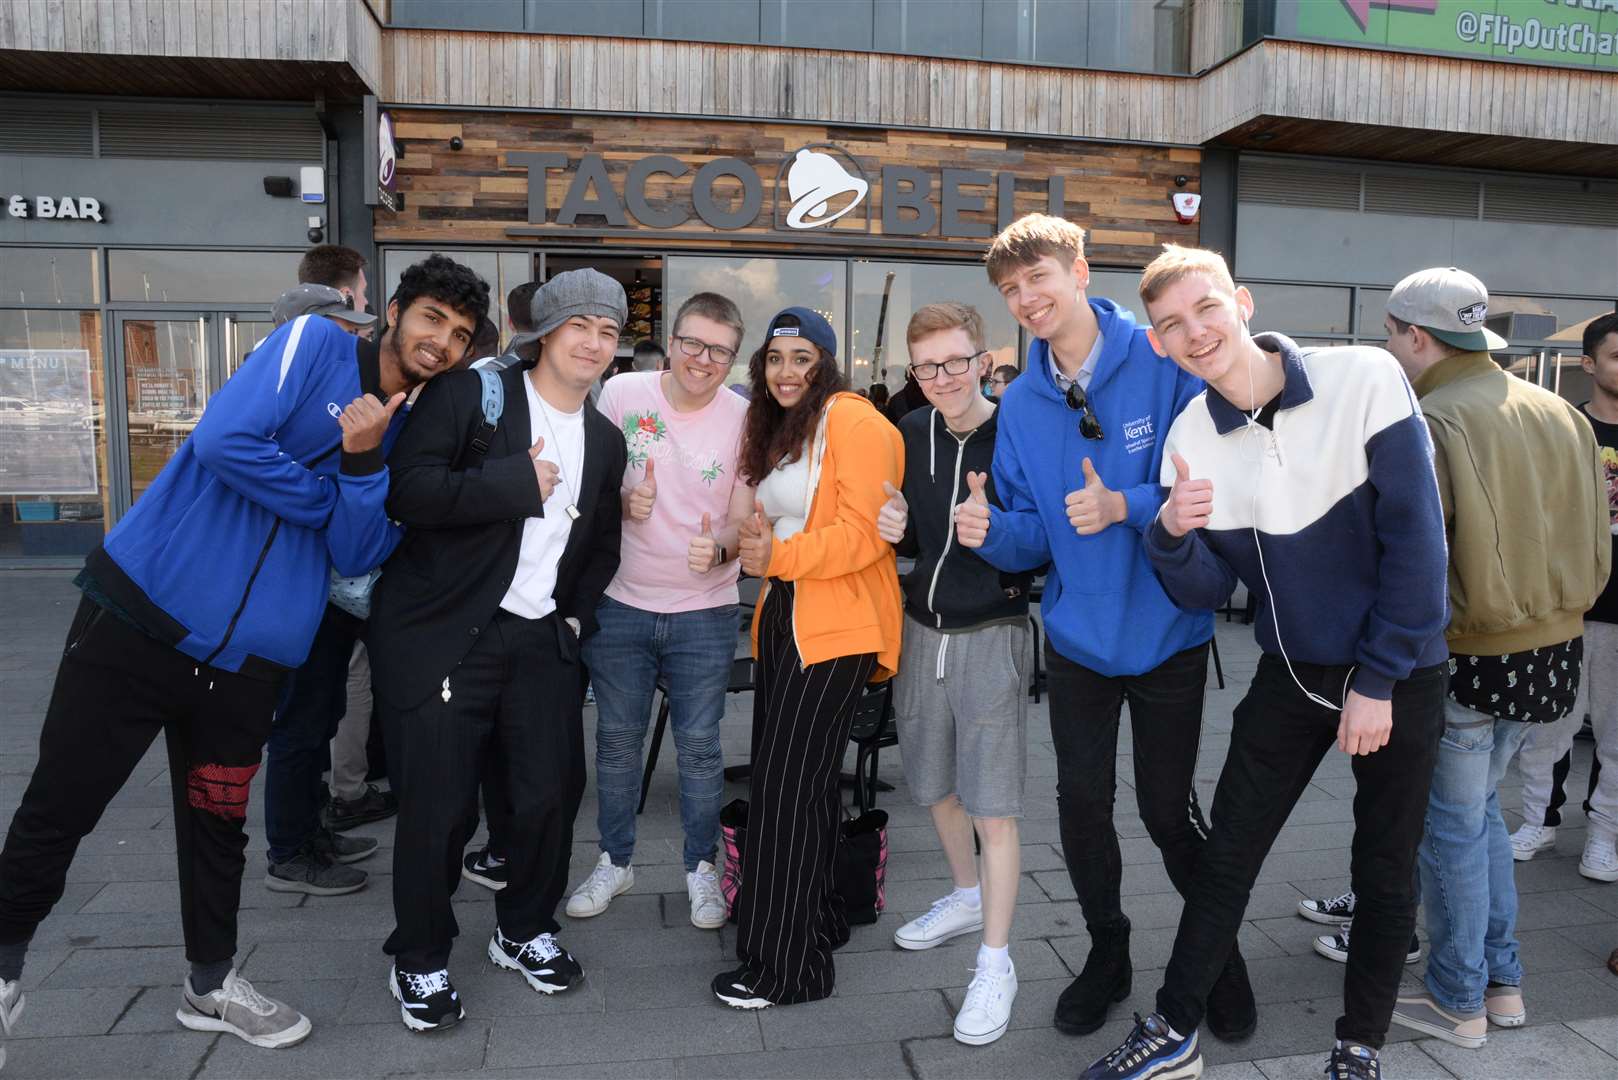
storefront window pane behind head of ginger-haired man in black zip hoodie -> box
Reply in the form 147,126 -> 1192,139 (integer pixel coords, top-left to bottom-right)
843,261 -> 1021,390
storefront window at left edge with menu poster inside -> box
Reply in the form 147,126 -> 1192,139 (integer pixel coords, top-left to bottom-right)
0,308 -> 108,557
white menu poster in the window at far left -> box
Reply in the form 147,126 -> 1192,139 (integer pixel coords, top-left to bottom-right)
0,348 -> 100,495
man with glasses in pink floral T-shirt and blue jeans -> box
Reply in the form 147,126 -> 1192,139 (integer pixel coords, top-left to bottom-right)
568,293 -> 752,929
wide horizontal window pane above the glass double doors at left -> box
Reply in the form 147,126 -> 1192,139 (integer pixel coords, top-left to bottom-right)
107,251 -> 303,304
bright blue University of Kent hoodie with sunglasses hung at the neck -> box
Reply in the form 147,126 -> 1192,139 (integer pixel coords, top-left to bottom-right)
979,298 -> 1214,677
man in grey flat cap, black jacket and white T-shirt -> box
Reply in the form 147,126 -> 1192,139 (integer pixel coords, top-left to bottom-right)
369,270 -> 628,1031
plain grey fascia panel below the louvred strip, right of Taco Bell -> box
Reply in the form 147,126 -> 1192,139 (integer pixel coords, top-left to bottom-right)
1236,202 -> 1618,296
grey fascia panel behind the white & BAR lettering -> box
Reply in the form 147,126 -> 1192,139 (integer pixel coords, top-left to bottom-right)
0,155 -> 328,247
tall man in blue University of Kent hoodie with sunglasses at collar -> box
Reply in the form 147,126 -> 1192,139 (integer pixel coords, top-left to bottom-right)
956,214 -> 1257,1040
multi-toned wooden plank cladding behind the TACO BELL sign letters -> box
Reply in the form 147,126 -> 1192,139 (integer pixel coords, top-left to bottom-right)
375,110 -> 1201,266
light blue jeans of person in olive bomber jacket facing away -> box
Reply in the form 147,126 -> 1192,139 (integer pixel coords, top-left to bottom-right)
1417,699 -> 1529,1012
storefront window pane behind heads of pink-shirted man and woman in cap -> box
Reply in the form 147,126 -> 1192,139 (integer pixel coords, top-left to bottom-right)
663,256 -> 847,384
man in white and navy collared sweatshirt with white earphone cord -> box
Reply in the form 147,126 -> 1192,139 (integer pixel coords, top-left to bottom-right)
1082,244 -> 1446,1080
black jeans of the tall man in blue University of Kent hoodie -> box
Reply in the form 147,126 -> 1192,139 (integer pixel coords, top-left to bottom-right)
1045,640 -> 1209,934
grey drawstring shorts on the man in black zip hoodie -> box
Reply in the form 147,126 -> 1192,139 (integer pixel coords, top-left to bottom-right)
893,615 -> 1029,818
